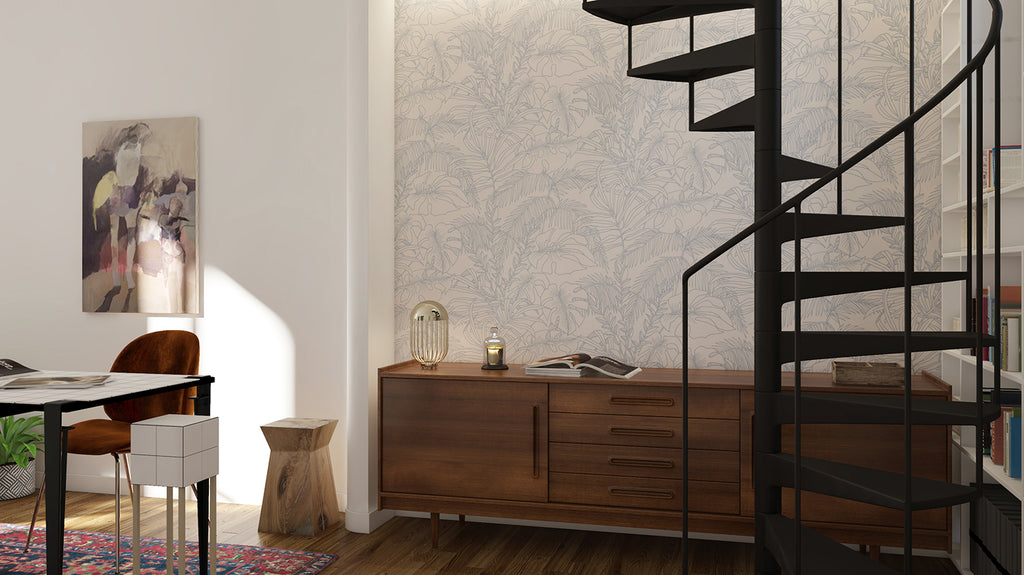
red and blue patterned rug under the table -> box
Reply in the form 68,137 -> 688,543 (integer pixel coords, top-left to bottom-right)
0,523 -> 336,575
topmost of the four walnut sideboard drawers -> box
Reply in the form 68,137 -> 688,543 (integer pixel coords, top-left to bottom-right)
549,384 -> 739,419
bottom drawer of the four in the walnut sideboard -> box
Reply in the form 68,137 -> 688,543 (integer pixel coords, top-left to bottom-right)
548,473 -> 739,515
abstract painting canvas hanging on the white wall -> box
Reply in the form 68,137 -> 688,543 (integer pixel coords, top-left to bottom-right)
82,118 -> 200,314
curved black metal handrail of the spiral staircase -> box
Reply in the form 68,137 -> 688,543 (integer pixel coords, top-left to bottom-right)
683,0 -> 1002,284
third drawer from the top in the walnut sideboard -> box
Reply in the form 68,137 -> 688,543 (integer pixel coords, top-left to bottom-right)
548,443 -> 739,483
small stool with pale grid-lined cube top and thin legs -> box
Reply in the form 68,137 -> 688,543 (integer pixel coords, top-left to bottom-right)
131,413 -> 219,575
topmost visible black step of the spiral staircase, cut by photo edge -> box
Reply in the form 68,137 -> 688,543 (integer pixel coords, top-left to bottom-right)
583,0 -> 754,26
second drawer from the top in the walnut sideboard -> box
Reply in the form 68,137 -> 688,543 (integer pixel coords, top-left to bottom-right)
549,413 -> 739,451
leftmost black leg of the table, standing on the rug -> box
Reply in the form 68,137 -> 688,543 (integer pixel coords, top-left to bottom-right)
43,402 -> 67,575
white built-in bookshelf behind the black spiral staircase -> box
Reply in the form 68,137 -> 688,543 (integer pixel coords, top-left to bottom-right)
940,0 -> 1024,574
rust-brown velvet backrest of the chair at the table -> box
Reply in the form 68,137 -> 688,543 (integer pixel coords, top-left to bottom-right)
103,329 -> 199,423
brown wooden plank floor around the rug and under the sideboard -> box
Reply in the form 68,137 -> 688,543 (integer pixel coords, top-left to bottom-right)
0,487 -> 957,575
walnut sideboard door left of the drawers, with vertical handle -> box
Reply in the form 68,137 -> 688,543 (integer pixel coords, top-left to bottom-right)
381,378 -> 548,501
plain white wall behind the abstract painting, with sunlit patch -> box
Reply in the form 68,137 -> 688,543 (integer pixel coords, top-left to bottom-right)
0,0 -> 348,505
